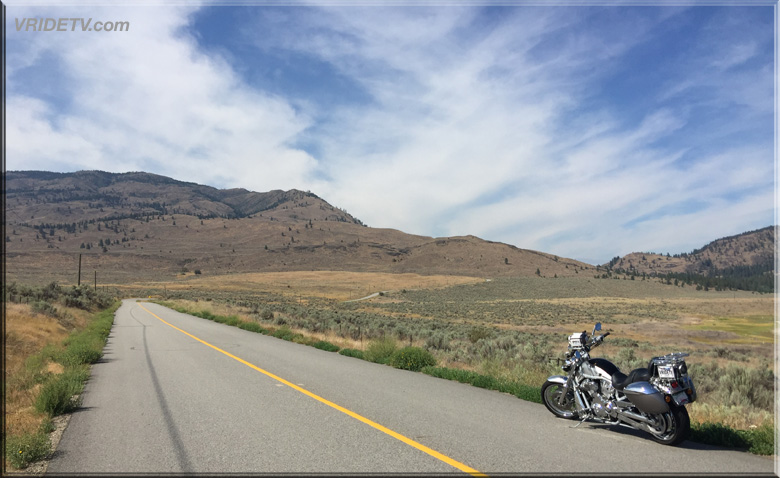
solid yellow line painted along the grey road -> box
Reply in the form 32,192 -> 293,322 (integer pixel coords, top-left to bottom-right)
138,303 -> 487,476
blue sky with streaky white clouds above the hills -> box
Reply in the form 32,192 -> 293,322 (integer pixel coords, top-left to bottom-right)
6,2 -> 776,264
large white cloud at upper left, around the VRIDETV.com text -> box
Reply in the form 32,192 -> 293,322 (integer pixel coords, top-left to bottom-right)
7,7 -> 316,190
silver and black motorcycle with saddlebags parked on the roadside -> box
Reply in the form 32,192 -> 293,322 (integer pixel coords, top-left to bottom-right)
542,322 -> 696,445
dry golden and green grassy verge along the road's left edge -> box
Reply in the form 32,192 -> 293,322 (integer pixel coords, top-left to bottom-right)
3,284 -> 118,469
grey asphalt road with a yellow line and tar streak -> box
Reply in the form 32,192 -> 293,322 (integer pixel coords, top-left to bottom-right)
47,300 -> 775,476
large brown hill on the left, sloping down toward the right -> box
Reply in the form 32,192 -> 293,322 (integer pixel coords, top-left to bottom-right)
5,171 -> 593,283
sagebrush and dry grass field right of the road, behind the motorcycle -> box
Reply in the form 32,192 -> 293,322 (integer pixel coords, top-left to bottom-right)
7,272 -> 776,462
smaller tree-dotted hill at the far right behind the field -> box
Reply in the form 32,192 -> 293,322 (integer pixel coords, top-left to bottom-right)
604,226 -> 775,292
